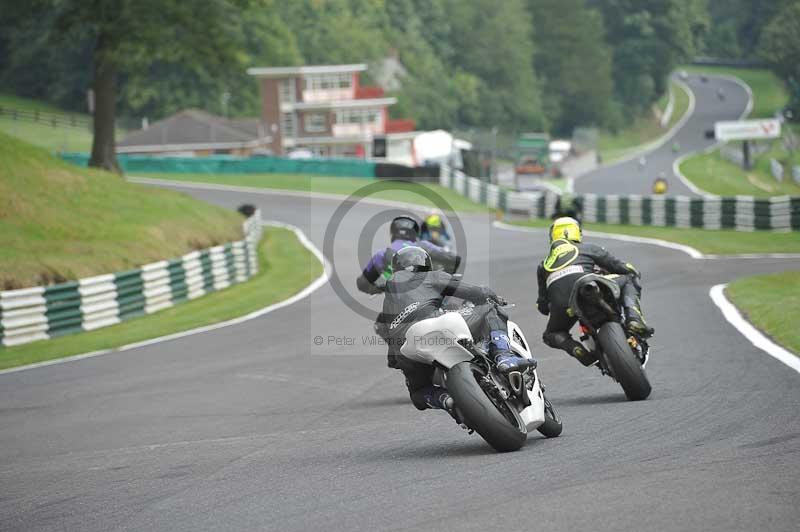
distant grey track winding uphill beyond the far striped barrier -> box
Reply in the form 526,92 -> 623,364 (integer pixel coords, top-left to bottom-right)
575,73 -> 749,196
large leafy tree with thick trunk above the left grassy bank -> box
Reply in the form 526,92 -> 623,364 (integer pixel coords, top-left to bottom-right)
25,0 -> 255,172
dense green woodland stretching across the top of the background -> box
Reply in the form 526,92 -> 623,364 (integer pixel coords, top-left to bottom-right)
0,0 -> 764,145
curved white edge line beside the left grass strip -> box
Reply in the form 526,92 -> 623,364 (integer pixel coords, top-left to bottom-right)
0,220 -> 331,375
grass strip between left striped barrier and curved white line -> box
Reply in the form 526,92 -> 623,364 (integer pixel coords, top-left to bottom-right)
0,227 -> 322,369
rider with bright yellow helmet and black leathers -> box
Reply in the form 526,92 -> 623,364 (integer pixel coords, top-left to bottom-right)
536,218 -> 654,366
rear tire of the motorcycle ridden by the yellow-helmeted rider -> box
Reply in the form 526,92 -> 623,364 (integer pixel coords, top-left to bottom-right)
597,321 -> 652,401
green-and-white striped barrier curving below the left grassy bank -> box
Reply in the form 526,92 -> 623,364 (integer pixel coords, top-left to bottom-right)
0,210 -> 261,346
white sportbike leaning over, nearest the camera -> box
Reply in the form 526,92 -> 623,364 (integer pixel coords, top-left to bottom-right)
400,304 -> 562,452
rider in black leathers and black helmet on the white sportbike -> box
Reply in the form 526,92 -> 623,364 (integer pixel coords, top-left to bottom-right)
375,246 -> 535,417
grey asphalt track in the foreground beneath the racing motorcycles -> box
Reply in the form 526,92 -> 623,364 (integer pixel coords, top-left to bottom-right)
0,183 -> 800,532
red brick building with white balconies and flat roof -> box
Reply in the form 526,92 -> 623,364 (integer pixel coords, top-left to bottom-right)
247,64 -> 414,157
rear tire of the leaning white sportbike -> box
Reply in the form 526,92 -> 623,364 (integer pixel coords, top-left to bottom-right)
447,362 -> 528,453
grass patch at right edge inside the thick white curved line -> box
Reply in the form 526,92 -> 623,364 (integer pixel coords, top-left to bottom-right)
725,271 -> 800,355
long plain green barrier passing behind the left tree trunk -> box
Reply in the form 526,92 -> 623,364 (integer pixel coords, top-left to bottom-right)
60,153 -> 375,177
